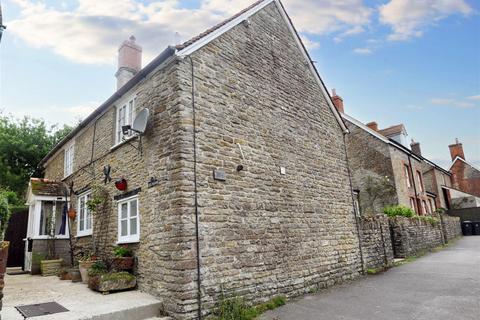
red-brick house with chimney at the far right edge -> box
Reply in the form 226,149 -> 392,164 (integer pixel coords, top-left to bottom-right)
448,139 -> 480,197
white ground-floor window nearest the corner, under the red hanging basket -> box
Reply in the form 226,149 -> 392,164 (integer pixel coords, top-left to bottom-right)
118,196 -> 140,243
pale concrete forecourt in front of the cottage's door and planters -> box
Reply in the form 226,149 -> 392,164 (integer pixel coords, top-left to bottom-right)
1,274 -> 161,320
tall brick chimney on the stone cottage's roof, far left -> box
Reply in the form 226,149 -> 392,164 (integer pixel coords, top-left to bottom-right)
115,36 -> 142,90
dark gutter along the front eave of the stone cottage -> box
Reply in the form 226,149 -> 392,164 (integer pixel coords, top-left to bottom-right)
38,46 -> 175,168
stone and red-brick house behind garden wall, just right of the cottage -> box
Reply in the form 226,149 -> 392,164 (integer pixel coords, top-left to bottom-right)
332,91 -> 451,215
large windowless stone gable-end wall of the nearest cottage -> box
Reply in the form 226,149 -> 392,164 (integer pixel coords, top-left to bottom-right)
181,3 -> 361,318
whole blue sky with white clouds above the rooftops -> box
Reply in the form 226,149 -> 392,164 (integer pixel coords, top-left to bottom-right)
0,0 -> 480,167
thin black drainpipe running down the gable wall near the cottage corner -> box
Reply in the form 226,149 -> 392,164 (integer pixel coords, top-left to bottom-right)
188,56 -> 202,320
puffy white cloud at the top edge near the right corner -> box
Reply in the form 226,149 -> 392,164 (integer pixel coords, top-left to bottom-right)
379,0 -> 472,41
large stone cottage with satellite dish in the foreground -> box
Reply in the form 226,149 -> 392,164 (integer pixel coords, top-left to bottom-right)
31,0 -> 362,319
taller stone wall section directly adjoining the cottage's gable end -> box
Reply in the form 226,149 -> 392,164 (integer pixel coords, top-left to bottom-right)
360,215 -> 393,270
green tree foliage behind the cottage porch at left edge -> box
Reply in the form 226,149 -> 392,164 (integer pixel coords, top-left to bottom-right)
0,114 -> 72,197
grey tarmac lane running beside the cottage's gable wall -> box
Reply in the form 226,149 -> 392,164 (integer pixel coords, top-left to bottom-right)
259,236 -> 480,320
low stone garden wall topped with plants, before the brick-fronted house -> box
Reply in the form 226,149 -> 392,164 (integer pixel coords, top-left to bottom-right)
390,217 -> 444,258
